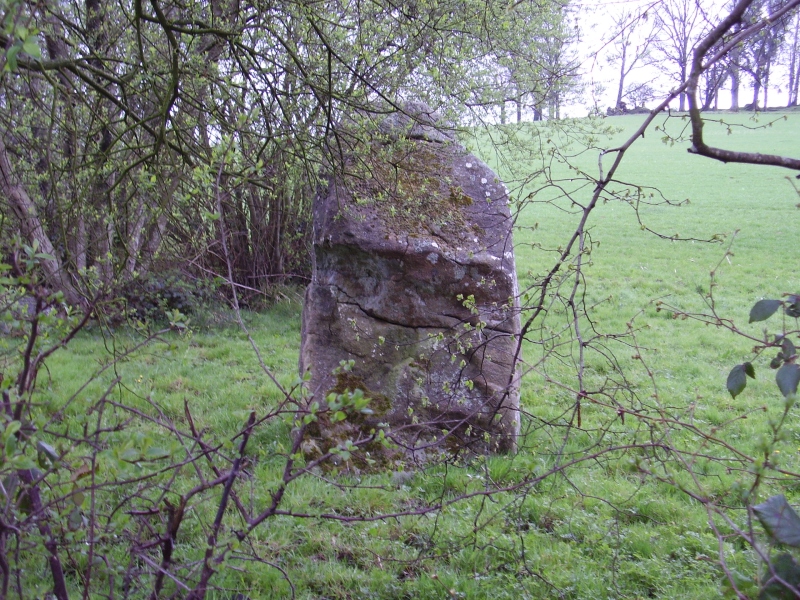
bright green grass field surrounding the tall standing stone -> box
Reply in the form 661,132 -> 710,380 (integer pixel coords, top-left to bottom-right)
15,113 -> 800,600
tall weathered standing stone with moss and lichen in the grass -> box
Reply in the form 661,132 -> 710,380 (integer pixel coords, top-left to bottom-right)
300,108 -> 520,451
